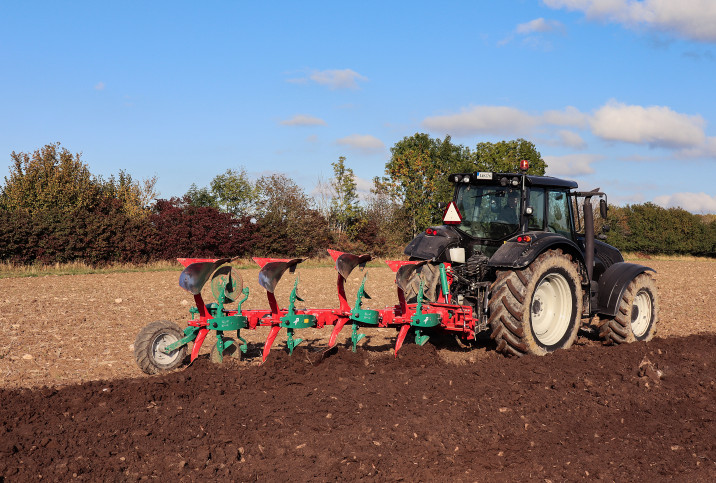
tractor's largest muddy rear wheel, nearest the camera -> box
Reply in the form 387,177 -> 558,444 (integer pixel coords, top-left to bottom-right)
489,249 -> 582,356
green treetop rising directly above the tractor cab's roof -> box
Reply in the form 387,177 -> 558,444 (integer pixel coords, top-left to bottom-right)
472,138 -> 547,175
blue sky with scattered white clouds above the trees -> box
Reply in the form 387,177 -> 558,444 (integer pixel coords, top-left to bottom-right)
0,0 -> 716,213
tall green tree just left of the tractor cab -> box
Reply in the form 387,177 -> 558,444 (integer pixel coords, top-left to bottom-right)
382,133 -> 472,235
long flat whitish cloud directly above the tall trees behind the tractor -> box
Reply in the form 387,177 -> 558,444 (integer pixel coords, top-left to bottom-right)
422,106 -> 538,136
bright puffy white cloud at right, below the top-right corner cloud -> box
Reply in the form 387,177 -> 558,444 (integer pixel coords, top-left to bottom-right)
590,101 -> 706,148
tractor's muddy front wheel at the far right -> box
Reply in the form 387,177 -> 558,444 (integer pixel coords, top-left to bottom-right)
599,273 -> 659,345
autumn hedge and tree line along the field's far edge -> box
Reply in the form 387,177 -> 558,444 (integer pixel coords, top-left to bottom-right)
0,140 -> 716,265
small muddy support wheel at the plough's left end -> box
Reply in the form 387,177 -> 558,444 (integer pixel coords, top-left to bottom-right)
134,320 -> 187,374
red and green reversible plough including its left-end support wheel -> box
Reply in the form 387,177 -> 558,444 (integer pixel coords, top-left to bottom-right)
135,250 -> 477,374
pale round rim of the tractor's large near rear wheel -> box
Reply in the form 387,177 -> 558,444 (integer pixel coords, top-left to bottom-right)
530,273 -> 572,346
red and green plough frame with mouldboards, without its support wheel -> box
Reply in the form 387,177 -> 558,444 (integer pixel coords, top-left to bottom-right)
179,250 -> 477,361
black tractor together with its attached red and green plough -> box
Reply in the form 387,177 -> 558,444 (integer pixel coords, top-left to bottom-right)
134,161 -> 659,374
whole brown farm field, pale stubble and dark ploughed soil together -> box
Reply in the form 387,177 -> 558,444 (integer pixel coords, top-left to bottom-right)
0,260 -> 716,481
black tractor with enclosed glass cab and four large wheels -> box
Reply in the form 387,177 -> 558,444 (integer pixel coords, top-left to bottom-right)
405,161 -> 659,356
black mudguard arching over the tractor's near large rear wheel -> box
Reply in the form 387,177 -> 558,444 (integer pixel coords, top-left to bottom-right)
487,232 -> 584,269
